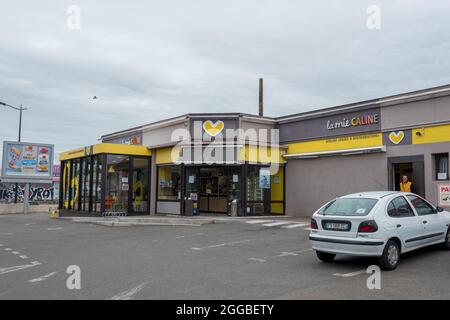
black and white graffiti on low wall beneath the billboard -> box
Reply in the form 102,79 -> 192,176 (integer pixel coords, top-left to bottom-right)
0,183 -> 59,202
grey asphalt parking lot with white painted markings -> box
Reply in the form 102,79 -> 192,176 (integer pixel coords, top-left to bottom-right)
0,214 -> 450,300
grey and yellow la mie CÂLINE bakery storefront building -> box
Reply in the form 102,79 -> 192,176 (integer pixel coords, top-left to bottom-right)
60,86 -> 450,217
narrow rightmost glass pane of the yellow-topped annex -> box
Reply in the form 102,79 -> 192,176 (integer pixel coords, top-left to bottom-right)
132,158 -> 150,212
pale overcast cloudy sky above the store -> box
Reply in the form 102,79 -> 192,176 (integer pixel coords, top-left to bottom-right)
0,0 -> 450,159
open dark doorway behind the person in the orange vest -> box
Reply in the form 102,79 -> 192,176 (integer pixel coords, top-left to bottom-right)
388,156 -> 425,197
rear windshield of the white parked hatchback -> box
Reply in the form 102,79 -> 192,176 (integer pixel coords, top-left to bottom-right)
319,198 -> 378,216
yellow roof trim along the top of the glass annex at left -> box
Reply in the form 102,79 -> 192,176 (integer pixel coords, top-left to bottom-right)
59,143 -> 152,161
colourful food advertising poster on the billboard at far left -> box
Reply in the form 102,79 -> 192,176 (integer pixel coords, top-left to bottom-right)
1,141 -> 54,183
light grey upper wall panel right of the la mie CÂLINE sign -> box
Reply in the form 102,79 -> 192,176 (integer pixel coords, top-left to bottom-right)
381,96 -> 450,130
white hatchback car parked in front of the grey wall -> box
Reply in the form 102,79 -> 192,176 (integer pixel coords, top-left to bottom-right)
309,191 -> 450,270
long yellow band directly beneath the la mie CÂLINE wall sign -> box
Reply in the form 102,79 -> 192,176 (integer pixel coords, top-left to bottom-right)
287,132 -> 383,154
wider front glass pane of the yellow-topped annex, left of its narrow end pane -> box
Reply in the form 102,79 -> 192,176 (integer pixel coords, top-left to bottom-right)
105,155 -> 130,212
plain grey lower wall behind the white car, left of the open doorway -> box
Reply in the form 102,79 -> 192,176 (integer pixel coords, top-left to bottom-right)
286,153 -> 387,217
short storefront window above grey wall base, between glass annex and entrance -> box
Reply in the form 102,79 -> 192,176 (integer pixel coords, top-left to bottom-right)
158,166 -> 181,201
